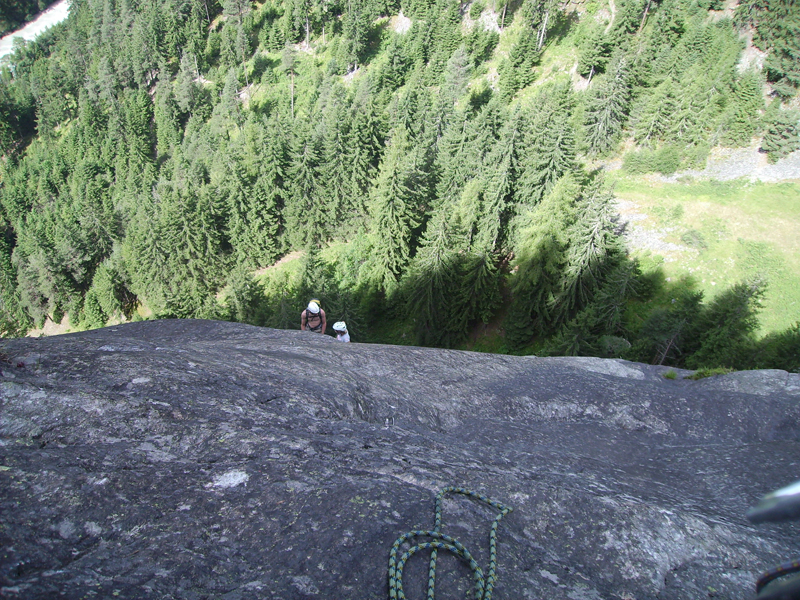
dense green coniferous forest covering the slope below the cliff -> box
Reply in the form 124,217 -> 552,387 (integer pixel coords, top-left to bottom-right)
0,0 -> 800,371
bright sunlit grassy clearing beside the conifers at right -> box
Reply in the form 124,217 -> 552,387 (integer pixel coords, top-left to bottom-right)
616,175 -> 800,334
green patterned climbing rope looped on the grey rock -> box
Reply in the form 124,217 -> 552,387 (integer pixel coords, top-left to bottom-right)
389,487 -> 513,600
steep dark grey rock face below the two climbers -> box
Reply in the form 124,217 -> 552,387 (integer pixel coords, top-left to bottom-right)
0,320 -> 800,600
